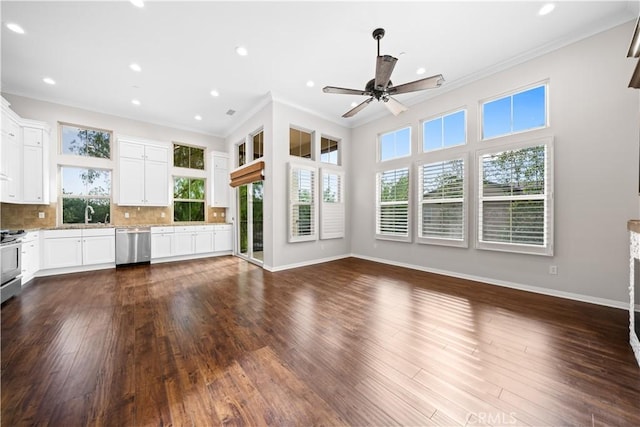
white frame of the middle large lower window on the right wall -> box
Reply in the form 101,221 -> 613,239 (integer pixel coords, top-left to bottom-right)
416,152 -> 470,248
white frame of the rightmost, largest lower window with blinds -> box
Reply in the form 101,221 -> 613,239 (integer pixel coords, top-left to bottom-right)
476,136 -> 554,256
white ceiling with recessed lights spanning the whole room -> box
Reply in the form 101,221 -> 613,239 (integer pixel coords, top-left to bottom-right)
1,0 -> 638,136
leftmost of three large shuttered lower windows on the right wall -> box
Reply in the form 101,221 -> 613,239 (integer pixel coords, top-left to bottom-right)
376,168 -> 409,241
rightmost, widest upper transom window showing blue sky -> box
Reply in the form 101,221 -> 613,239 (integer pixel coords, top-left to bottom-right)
482,84 -> 547,139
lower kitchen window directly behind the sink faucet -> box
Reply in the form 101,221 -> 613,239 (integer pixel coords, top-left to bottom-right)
60,166 -> 111,224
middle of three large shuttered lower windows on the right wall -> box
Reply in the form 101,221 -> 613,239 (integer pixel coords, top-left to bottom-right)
418,159 -> 466,246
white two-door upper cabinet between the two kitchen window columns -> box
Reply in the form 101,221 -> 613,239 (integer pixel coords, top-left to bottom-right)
118,138 -> 169,206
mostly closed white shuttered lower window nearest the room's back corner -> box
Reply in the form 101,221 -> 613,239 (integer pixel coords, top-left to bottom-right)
320,168 -> 345,239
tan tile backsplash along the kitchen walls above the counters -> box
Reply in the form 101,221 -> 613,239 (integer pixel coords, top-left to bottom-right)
0,203 -> 227,230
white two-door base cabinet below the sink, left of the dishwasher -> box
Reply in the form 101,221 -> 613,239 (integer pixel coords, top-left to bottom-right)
42,228 -> 116,269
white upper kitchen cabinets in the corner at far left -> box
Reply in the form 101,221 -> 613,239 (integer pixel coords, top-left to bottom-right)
0,99 -> 49,204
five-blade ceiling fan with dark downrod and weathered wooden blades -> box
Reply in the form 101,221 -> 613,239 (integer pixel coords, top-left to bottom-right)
322,28 -> 444,118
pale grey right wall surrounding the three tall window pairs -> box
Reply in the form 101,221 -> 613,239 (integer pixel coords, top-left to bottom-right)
348,23 -> 639,304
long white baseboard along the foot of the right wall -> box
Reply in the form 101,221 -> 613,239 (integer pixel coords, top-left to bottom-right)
351,254 -> 629,310
